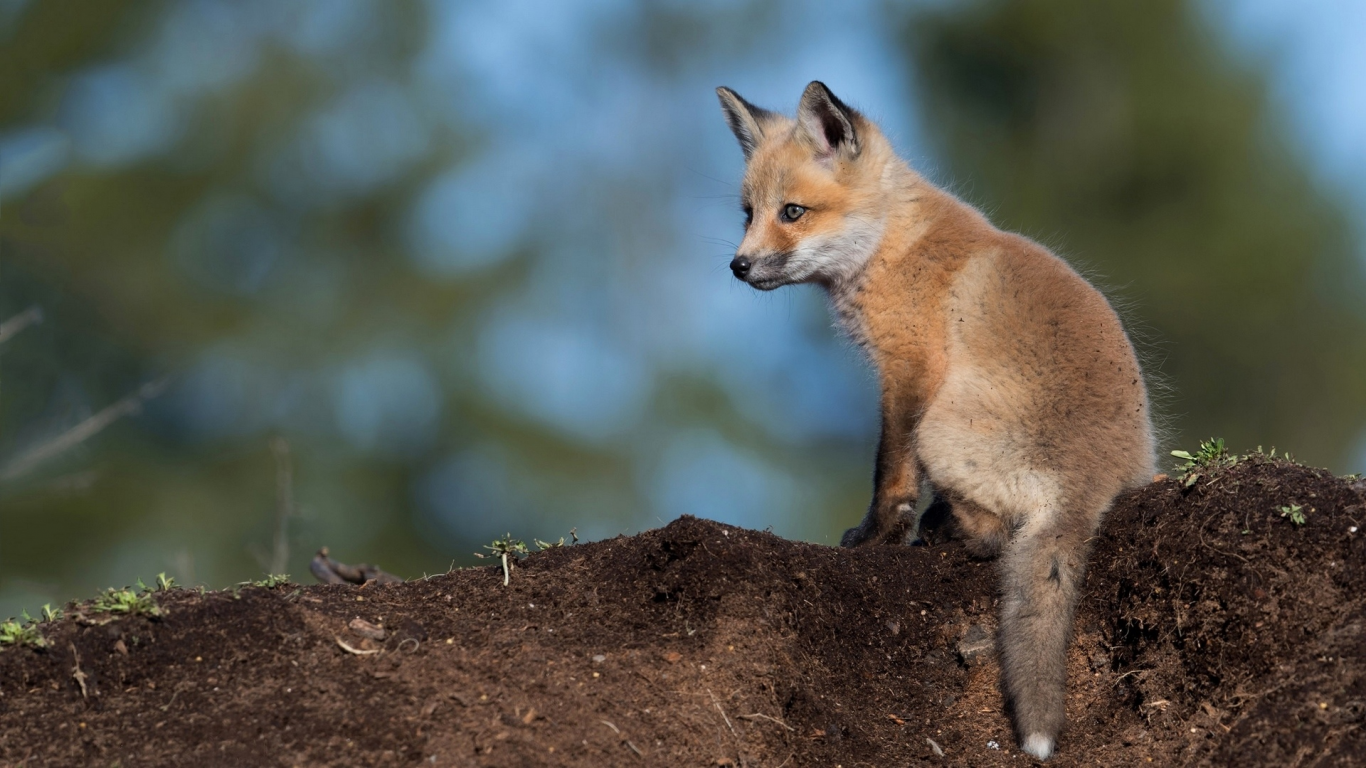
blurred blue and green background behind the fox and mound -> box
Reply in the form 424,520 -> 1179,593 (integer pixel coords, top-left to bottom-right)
0,0 -> 1366,616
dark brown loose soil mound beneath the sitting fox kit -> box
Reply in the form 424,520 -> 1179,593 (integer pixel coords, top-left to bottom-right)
0,459 -> 1366,768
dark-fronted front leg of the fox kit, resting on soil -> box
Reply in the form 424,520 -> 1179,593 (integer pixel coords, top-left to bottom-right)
840,396 -> 921,547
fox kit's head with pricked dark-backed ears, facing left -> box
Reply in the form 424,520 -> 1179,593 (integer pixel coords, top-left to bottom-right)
716,82 -> 896,291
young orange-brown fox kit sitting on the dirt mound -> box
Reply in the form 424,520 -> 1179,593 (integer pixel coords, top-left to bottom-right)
717,82 -> 1154,758
